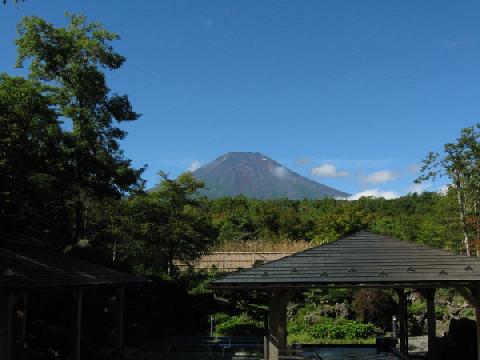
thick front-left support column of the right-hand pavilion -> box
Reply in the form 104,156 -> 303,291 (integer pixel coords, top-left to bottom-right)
266,290 -> 295,360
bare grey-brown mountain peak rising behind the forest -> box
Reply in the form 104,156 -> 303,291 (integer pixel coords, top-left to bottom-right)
188,152 -> 349,199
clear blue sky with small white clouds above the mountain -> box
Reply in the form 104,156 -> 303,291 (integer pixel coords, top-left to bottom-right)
0,0 -> 480,196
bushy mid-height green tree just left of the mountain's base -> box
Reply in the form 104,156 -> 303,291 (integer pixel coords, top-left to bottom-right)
127,172 -> 216,274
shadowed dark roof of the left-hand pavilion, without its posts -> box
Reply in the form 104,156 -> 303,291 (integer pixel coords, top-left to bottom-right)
0,246 -> 145,289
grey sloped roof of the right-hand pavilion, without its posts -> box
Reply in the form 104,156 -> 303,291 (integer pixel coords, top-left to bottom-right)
212,231 -> 480,289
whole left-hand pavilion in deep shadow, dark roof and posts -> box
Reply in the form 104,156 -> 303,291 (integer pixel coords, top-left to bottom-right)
0,245 -> 144,360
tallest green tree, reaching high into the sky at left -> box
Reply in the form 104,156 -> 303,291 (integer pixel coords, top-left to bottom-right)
16,15 -> 143,242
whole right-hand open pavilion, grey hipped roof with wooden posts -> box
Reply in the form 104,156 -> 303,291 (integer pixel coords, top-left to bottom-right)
212,231 -> 480,360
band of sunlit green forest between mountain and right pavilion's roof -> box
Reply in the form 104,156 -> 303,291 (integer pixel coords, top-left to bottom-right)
206,192 -> 462,251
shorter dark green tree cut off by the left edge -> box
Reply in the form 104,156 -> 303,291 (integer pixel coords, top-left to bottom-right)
0,74 -> 68,246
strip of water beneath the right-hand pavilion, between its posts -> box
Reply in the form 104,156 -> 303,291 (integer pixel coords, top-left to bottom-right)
313,347 -> 398,360
